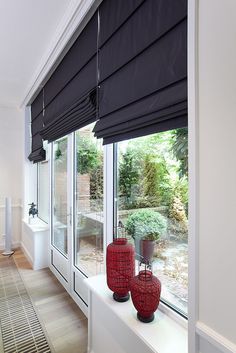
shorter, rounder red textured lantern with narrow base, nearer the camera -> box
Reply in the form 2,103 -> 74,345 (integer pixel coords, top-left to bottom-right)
130,270 -> 161,322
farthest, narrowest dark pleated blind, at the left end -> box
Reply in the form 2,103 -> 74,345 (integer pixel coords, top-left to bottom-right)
28,90 -> 46,163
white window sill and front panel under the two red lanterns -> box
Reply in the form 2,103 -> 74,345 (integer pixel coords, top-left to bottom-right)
85,275 -> 188,353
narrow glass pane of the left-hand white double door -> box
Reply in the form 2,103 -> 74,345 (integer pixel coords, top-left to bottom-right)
53,137 -> 68,255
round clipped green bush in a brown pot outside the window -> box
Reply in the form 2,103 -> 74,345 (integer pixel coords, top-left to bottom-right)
126,209 -> 167,263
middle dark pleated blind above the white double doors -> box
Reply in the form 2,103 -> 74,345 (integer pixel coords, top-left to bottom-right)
41,13 -> 98,142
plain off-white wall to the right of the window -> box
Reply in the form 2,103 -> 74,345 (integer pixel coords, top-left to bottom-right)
198,0 -> 236,353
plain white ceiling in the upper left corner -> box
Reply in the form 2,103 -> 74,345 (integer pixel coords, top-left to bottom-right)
0,0 -> 74,107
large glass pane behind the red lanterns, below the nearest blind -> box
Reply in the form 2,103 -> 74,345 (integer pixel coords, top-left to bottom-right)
114,129 -> 188,315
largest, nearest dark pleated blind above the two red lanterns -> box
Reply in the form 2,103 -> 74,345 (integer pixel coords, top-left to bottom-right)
94,0 -> 187,144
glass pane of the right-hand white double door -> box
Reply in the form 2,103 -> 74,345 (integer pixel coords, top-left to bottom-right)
75,124 -> 103,276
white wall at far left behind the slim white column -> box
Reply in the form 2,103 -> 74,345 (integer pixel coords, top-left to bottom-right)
0,107 -> 24,248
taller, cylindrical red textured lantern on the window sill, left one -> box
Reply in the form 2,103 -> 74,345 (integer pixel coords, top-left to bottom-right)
106,238 -> 134,302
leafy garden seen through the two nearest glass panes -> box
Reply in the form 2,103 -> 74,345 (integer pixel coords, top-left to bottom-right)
54,128 -> 188,314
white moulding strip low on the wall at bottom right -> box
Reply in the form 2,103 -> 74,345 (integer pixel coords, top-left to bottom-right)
196,321 -> 236,353
